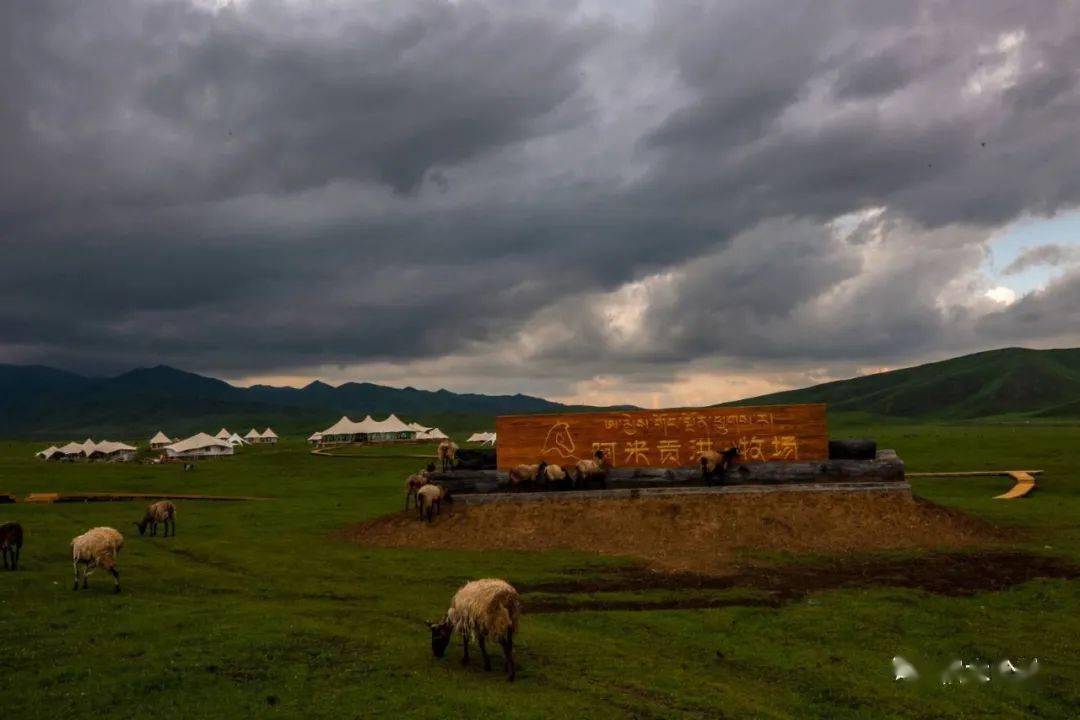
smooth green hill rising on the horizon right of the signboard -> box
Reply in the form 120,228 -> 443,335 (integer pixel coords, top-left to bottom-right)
728,348 -> 1080,420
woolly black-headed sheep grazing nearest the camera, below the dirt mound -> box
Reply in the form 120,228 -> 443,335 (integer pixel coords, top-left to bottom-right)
428,578 -> 522,682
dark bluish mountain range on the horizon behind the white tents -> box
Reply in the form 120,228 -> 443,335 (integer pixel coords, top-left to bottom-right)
0,365 -> 577,438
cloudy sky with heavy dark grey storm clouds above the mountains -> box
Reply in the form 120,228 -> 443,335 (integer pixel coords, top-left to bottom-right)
0,0 -> 1080,407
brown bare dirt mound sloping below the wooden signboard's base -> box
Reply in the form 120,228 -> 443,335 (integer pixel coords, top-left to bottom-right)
343,492 -> 999,572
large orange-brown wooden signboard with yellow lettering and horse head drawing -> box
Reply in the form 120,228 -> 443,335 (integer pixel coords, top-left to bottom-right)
495,405 -> 828,470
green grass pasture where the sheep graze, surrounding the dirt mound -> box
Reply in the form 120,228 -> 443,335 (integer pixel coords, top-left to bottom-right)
0,417 -> 1080,719
